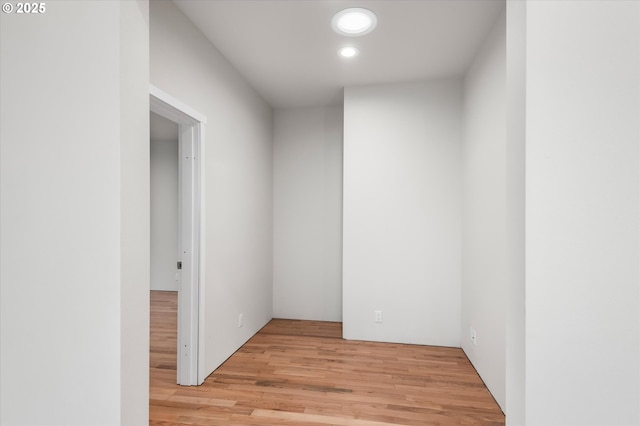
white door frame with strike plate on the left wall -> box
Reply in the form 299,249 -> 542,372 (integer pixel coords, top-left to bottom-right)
149,85 -> 207,386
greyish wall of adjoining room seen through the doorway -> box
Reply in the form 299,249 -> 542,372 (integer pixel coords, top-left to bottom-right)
151,113 -> 179,291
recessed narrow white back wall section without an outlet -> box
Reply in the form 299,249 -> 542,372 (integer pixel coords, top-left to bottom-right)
273,107 -> 343,321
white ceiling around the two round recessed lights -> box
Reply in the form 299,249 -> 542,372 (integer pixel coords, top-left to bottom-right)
174,0 -> 505,108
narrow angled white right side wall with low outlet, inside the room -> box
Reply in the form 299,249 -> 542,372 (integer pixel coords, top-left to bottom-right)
461,9 -> 508,410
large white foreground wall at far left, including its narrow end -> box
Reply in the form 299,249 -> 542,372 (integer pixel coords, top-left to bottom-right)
0,2 -> 149,426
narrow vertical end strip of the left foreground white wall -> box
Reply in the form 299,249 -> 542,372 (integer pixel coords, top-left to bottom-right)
119,0 -> 150,426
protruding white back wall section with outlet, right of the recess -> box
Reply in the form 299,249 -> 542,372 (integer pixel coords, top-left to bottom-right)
343,79 -> 462,346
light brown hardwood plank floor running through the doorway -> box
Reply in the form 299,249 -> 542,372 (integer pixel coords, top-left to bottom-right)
149,292 -> 504,426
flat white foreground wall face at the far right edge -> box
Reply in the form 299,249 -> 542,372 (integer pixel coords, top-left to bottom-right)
526,1 -> 640,425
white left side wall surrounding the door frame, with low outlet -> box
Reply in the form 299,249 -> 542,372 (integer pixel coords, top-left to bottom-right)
150,1 -> 273,371
